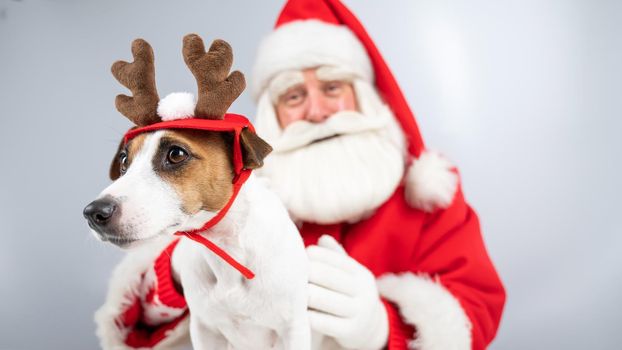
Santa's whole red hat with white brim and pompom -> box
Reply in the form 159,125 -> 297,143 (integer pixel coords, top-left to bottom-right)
251,0 -> 458,211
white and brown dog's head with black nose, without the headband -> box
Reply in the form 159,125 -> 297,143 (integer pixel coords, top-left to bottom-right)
84,129 -> 271,248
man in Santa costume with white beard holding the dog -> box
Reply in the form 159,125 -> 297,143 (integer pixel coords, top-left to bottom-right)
96,0 -> 505,350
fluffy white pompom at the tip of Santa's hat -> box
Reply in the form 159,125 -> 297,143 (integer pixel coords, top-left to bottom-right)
405,151 -> 458,212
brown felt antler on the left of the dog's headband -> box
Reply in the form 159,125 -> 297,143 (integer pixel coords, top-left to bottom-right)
111,39 -> 160,126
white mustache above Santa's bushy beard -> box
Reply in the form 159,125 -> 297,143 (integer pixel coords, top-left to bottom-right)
272,111 -> 391,153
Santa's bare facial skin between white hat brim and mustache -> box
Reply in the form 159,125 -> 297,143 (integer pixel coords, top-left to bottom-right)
275,69 -> 357,128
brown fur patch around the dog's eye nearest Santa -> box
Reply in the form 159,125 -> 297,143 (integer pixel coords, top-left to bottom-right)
152,130 -> 234,214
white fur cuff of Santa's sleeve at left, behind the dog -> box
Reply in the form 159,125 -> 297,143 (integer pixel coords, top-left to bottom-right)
95,237 -> 189,350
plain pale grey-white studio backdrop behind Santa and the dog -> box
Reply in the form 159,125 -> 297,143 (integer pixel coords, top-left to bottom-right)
0,0 -> 622,350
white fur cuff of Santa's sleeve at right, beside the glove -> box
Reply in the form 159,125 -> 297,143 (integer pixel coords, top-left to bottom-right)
377,273 -> 471,350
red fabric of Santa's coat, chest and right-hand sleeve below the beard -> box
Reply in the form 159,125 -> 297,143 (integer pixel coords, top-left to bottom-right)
302,187 -> 505,350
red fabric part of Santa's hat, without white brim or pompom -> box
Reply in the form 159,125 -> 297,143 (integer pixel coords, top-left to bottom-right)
275,0 -> 424,157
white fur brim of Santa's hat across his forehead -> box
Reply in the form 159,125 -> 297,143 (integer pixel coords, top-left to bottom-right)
251,19 -> 374,101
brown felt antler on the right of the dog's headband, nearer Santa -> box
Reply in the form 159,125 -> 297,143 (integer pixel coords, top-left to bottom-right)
183,34 -> 246,119
